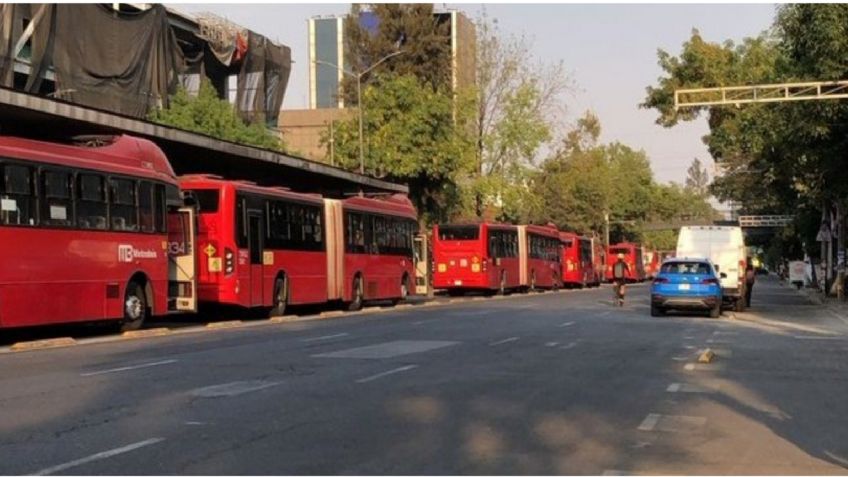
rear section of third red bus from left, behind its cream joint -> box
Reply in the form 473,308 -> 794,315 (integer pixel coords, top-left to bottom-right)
433,223 -> 521,294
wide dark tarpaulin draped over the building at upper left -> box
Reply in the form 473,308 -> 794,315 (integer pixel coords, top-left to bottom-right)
53,4 -> 184,117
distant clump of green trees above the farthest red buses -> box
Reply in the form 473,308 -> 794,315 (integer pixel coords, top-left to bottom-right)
535,112 -> 715,248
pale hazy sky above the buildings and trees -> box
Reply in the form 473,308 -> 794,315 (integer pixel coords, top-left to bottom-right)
176,3 -> 775,183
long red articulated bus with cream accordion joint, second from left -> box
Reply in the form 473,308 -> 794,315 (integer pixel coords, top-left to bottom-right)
180,175 -> 417,315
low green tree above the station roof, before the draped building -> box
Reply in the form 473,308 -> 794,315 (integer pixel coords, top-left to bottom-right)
149,79 -> 284,151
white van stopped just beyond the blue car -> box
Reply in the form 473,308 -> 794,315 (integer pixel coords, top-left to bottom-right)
676,225 -> 747,311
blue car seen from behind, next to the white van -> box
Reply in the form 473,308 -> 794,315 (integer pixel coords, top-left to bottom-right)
651,258 -> 726,318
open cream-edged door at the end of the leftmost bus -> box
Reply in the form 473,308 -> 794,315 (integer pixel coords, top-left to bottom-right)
168,207 -> 197,313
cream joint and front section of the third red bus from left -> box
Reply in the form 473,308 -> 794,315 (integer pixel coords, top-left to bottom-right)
518,225 -> 562,291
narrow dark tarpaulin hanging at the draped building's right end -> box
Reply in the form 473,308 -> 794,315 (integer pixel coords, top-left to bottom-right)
236,31 -> 291,125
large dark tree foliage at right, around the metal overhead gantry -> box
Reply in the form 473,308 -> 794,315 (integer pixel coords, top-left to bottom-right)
643,4 -> 848,251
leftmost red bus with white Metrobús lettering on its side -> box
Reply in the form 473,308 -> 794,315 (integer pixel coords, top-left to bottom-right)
0,136 -> 195,330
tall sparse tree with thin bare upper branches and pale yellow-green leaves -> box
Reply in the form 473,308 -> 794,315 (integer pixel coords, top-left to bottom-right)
464,11 -> 571,221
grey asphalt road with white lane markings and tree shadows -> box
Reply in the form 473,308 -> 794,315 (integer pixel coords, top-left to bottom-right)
0,280 -> 848,475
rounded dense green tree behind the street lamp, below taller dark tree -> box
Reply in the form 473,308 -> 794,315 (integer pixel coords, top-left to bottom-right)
324,75 -> 474,223
